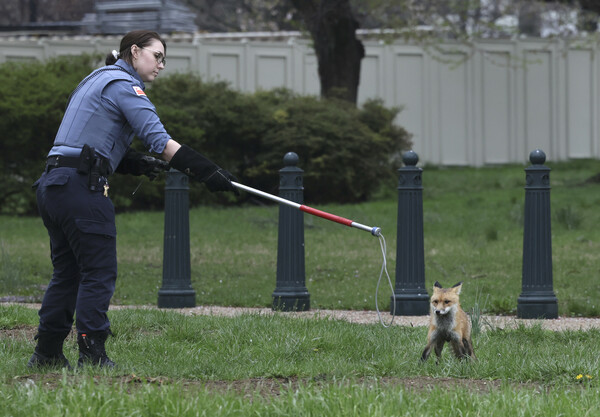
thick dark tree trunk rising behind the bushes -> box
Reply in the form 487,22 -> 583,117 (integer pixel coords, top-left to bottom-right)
290,0 -> 365,104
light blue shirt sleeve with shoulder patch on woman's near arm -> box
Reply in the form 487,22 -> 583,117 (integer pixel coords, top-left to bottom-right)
103,80 -> 171,154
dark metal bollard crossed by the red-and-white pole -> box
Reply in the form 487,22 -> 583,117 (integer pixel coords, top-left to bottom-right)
273,152 -> 310,311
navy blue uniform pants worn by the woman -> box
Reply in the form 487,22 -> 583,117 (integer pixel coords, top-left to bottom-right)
37,168 -> 117,333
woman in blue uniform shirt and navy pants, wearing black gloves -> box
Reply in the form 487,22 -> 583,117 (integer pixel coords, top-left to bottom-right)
28,30 -> 237,368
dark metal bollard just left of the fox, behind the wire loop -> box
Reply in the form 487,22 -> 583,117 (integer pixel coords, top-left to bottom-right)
390,151 -> 429,316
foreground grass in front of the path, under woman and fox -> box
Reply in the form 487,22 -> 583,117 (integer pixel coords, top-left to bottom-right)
0,306 -> 600,416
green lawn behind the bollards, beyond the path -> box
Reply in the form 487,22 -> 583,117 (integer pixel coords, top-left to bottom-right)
0,160 -> 600,316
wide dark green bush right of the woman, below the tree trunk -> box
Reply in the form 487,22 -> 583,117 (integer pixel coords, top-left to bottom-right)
149,78 -> 410,203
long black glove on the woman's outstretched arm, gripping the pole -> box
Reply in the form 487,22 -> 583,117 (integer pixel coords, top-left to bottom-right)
169,145 -> 240,195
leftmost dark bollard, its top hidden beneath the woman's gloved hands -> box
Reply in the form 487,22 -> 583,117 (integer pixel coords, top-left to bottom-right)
158,169 -> 196,308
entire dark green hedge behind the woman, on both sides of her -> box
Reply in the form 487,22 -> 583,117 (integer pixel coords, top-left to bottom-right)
0,56 -> 410,213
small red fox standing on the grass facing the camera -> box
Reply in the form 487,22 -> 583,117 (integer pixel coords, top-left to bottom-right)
421,281 -> 476,361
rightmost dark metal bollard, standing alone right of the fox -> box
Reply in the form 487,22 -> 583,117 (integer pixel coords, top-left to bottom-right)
517,149 -> 558,319
